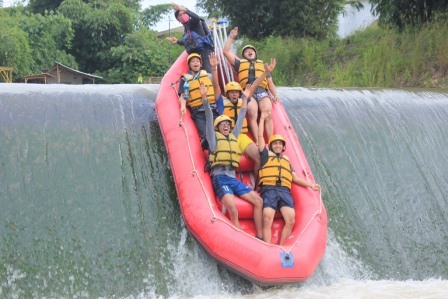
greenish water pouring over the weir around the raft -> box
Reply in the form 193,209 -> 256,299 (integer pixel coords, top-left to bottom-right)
0,84 -> 448,299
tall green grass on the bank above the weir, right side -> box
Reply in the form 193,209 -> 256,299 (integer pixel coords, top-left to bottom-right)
242,21 -> 448,88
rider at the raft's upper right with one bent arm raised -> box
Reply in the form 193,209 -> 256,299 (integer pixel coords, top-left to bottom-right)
222,27 -> 278,144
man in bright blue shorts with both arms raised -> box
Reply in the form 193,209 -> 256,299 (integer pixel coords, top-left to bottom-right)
200,82 -> 263,240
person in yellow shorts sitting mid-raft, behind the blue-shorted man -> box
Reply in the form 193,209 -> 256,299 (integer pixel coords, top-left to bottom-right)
216,58 -> 277,186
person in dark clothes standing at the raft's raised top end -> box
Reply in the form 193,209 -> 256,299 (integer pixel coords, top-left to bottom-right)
166,3 -> 214,73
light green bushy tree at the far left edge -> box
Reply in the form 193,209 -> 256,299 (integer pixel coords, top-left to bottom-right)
0,7 -> 76,79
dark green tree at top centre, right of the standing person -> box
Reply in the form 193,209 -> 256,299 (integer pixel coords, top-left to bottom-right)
198,0 -> 362,39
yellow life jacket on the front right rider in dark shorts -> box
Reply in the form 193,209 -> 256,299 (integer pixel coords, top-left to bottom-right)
258,151 -> 292,189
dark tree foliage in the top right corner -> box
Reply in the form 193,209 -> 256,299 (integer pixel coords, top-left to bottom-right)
370,0 -> 448,30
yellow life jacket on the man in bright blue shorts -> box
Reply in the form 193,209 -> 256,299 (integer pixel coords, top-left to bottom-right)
210,132 -> 241,168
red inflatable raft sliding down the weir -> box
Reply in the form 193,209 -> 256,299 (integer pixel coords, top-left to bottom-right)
156,52 -> 327,285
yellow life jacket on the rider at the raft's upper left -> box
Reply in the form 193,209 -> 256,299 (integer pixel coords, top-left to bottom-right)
183,70 -> 215,108
